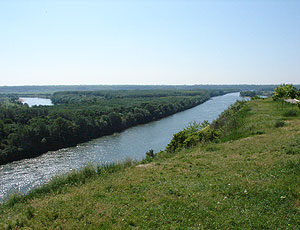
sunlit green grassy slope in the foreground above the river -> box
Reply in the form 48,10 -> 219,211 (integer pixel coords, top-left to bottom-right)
0,100 -> 300,229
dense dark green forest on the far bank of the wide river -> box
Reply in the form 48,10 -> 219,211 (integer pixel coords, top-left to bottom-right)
0,89 -> 233,164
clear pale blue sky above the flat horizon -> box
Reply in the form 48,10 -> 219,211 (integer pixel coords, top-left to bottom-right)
0,0 -> 300,86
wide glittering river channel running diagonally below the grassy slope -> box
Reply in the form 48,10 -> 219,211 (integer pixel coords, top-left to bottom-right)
0,93 -> 243,201
